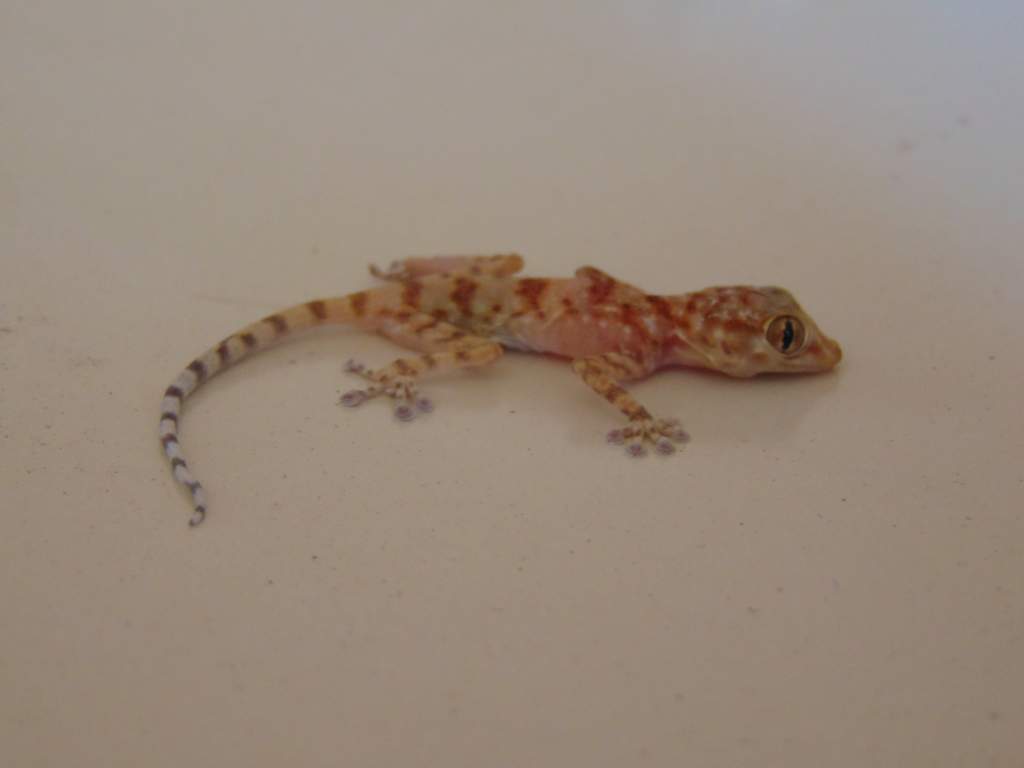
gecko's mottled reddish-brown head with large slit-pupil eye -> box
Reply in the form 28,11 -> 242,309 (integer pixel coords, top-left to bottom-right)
681,286 -> 843,377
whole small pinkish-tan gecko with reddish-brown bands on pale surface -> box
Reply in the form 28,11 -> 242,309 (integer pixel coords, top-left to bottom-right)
160,254 -> 843,526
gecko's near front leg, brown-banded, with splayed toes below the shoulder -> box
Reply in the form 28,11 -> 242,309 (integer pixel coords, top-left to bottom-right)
572,352 -> 689,457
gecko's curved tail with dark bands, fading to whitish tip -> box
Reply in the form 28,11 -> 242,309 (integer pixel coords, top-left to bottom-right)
160,292 -> 368,526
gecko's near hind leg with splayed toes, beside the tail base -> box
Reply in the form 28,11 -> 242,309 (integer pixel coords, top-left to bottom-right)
339,312 -> 503,421
